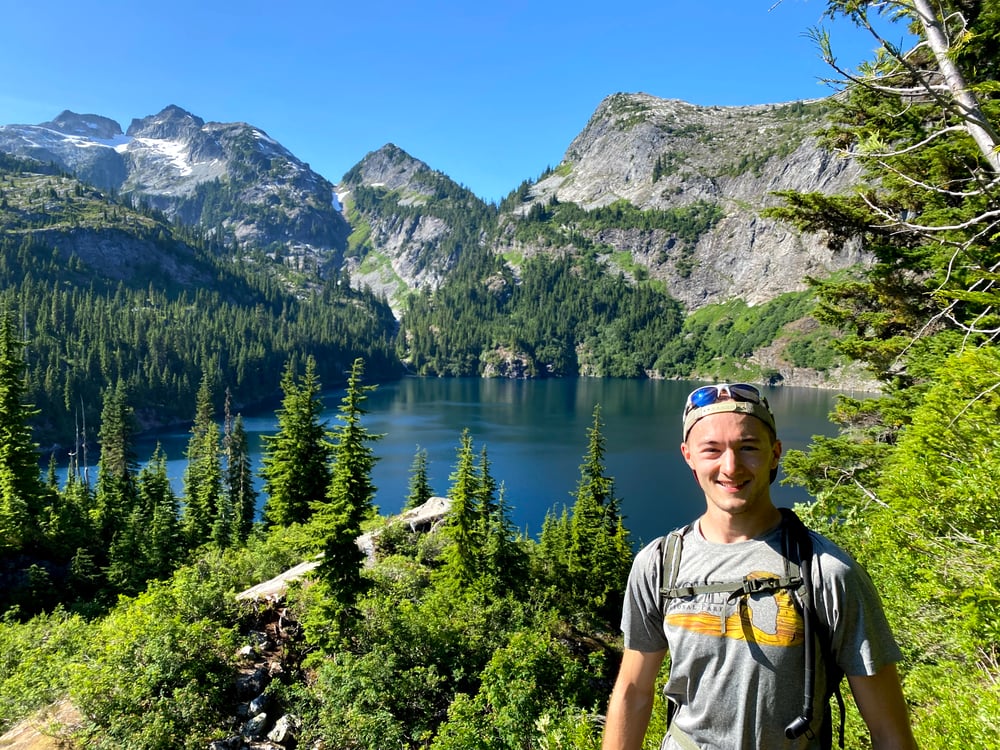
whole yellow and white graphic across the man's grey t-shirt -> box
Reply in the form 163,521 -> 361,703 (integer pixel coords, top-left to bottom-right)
667,572 -> 805,647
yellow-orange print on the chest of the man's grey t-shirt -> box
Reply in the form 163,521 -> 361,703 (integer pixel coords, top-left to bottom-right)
667,572 -> 805,646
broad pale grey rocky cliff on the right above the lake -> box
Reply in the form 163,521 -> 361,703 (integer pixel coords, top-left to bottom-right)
517,94 -> 865,309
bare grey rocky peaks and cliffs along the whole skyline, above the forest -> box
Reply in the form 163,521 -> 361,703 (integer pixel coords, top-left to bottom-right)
0,93 -> 866,314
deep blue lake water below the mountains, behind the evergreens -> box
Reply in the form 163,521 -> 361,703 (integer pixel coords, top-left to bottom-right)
64,378 -> 860,544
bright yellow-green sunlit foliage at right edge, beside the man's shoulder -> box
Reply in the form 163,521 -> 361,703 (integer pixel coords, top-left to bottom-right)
871,348 -> 1000,664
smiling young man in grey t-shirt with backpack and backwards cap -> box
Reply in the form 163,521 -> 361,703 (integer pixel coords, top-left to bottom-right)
603,383 -> 916,750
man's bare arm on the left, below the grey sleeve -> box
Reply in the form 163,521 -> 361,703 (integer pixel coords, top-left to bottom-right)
601,649 -> 667,750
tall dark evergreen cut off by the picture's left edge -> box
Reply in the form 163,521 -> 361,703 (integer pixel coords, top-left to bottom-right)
0,313 -> 49,555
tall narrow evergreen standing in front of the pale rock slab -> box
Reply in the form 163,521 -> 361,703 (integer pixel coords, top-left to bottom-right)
315,358 -> 381,612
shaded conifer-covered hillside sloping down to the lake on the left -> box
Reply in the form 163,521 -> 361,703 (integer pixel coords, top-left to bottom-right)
0,157 -> 400,444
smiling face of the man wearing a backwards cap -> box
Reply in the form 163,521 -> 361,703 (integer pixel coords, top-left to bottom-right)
681,412 -> 781,515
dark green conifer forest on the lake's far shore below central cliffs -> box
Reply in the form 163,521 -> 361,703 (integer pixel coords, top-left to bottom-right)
400,248 -> 683,377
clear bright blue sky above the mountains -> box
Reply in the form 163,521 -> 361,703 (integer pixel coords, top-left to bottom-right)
0,0 -> 903,200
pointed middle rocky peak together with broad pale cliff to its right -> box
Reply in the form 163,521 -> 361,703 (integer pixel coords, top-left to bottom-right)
339,94 -> 866,318
